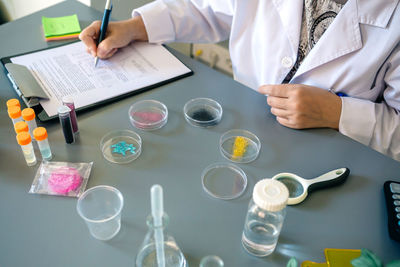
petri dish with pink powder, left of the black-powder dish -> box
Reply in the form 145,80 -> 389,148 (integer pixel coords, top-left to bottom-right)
128,100 -> 168,131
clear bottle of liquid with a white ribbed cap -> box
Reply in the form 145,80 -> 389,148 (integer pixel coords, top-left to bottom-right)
242,179 -> 289,257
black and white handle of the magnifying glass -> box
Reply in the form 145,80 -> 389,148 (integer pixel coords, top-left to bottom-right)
307,168 -> 350,192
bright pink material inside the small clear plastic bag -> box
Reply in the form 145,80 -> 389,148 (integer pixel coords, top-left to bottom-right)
47,167 -> 82,195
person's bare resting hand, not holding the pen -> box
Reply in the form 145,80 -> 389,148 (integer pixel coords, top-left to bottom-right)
258,84 -> 342,129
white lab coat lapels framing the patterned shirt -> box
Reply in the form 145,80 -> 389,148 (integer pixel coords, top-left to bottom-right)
274,0 -> 399,83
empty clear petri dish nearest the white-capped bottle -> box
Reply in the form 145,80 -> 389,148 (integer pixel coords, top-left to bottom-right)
201,163 -> 247,200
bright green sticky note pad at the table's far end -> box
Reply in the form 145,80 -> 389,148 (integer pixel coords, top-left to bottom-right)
42,14 -> 81,37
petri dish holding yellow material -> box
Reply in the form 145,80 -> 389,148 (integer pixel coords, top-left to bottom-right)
219,129 -> 261,163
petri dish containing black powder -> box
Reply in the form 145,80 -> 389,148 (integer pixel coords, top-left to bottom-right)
183,98 -> 222,127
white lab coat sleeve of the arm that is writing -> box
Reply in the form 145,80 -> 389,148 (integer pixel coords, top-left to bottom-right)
132,0 -> 233,43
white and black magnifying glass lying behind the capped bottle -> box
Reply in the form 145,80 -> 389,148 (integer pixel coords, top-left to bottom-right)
272,168 -> 350,205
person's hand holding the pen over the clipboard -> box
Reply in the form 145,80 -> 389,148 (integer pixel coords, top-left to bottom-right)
79,16 -> 148,58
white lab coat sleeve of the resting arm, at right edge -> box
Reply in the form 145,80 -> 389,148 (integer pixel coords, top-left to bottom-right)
339,44 -> 400,161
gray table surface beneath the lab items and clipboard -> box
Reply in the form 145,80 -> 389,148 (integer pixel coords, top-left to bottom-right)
0,1 -> 400,266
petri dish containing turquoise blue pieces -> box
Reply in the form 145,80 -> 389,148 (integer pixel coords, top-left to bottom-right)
100,130 -> 142,164
